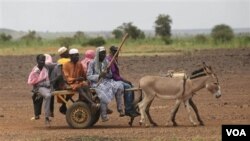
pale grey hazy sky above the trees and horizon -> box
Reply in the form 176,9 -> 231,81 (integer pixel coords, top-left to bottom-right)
0,0 -> 250,32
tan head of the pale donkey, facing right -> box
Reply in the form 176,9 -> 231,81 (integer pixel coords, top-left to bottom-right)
203,62 -> 221,98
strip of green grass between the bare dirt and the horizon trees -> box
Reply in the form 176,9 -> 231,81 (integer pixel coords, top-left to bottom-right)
0,37 -> 250,56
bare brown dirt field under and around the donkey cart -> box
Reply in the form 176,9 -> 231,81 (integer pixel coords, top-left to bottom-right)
0,48 -> 250,141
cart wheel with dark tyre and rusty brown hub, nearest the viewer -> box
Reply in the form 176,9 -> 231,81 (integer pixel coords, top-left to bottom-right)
66,102 -> 93,129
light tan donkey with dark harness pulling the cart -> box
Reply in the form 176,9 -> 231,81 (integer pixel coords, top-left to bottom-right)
137,63 -> 221,126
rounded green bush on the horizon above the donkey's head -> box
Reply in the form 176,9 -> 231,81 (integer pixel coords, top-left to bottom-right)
211,24 -> 234,43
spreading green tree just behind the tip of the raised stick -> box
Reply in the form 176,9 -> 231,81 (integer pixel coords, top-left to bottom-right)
117,22 -> 145,40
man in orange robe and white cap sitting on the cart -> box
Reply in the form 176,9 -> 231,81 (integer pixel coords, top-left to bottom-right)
63,48 -> 98,107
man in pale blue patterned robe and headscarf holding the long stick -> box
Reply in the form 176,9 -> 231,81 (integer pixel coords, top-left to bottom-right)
87,47 -> 125,122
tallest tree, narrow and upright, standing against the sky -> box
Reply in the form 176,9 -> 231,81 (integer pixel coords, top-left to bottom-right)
155,14 -> 172,44
